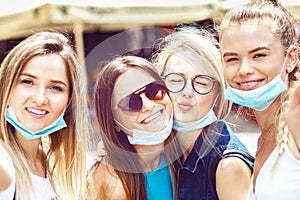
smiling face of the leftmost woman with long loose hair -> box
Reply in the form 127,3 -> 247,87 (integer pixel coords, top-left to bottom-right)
9,54 -> 70,131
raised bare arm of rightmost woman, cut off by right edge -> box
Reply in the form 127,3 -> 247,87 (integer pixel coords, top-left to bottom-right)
286,86 -> 300,160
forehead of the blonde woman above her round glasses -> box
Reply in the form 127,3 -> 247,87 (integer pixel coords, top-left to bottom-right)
165,51 -> 211,75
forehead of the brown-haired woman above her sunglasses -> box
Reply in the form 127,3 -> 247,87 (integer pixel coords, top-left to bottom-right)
112,68 -> 155,103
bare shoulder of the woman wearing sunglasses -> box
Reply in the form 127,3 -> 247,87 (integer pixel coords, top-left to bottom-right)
88,161 -> 126,200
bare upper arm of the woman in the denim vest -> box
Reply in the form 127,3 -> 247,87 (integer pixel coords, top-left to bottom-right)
216,157 -> 252,200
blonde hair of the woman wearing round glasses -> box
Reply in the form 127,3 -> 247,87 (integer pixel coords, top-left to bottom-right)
152,27 -> 231,119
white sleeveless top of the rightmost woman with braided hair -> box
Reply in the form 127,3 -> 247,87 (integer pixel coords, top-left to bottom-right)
248,146 -> 300,200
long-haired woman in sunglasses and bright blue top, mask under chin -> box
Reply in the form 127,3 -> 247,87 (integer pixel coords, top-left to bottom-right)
88,56 -> 177,200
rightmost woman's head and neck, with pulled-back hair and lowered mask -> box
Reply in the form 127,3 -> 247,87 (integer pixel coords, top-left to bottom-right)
220,1 -> 299,195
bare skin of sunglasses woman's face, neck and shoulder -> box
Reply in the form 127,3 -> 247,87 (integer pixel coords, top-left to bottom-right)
93,68 -> 172,200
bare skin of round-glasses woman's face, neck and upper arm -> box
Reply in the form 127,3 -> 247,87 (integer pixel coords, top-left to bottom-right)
164,52 -> 251,200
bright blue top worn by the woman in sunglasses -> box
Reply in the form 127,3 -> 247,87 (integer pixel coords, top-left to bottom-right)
144,155 -> 173,200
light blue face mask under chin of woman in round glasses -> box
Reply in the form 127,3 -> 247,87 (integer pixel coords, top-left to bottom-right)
173,109 -> 217,133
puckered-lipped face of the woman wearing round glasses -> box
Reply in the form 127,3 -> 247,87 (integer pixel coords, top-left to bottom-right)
164,52 -> 218,122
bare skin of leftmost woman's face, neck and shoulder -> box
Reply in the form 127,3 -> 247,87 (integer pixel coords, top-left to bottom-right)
0,54 -> 70,190
